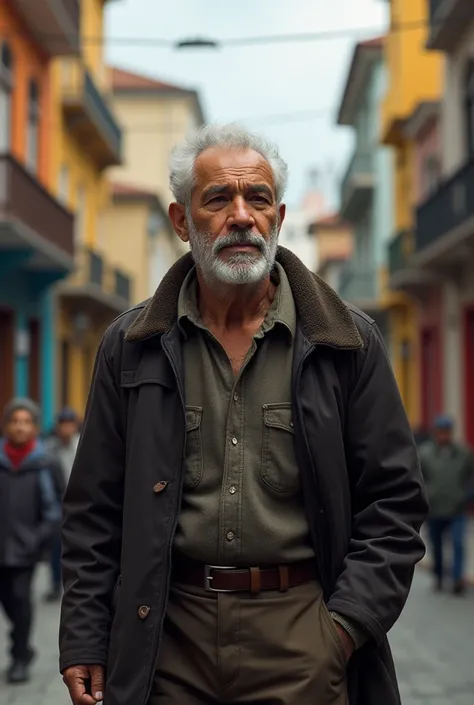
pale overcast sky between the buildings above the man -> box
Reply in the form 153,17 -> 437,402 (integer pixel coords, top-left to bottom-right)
107,0 -> 388,206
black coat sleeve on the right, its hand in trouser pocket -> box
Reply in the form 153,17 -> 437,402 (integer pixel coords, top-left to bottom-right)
328,325 -> 428,642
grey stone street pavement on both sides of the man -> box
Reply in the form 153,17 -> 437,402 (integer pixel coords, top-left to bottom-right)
0,568 -> 474,705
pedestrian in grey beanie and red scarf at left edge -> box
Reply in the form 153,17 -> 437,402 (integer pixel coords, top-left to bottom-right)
0,399 -> 60,683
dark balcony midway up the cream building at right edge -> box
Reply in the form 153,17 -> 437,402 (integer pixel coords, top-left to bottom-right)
415,153 -> 474,266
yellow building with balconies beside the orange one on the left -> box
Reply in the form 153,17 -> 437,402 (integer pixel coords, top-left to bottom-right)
50,0 -> 133,412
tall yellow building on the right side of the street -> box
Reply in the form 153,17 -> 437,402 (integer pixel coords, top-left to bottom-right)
380,0 -> 442,425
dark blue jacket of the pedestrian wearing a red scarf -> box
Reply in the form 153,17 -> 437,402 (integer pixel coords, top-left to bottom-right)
0,440 -> 61,567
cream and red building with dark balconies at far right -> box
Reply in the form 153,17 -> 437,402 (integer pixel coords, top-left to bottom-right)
394,0 -> 474,445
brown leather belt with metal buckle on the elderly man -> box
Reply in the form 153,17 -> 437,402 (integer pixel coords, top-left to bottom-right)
172,556 -> 316,594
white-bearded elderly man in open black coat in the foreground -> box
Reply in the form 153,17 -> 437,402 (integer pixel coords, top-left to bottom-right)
60,125 -> 427,705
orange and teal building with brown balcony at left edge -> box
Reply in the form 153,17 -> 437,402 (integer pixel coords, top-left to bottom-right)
0,0 -> 79,426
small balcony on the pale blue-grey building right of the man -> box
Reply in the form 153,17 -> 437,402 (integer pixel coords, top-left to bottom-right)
341,152 -> 374,221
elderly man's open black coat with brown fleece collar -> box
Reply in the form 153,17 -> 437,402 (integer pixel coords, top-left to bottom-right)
60,248 -> 427,705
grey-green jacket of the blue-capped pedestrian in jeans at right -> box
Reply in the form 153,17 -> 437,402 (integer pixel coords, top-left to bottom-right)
419,441 -> 474,517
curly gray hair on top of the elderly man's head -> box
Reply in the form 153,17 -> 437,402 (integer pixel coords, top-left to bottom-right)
169,123 -> 288,205
